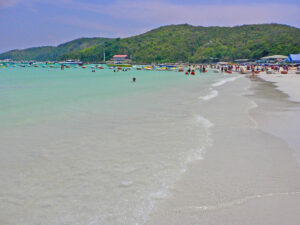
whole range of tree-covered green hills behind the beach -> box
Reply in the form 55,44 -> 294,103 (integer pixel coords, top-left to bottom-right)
0,24 -> 300,63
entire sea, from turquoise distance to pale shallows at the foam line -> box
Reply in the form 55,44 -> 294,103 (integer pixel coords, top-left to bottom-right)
0,67 -> 232,225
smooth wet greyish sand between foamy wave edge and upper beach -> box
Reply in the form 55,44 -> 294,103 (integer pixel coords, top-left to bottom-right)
147,77 -> 300,225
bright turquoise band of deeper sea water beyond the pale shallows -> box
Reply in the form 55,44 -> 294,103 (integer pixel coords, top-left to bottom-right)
0,68 -> 209,125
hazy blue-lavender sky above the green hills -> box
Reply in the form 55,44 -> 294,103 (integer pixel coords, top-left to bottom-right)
0,0 -> 300,52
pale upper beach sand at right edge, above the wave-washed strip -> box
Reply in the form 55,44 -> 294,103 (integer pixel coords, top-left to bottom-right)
249,76 -> 300,162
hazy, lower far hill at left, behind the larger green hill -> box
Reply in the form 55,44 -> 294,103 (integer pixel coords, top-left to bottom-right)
0,38 -> 110,61
